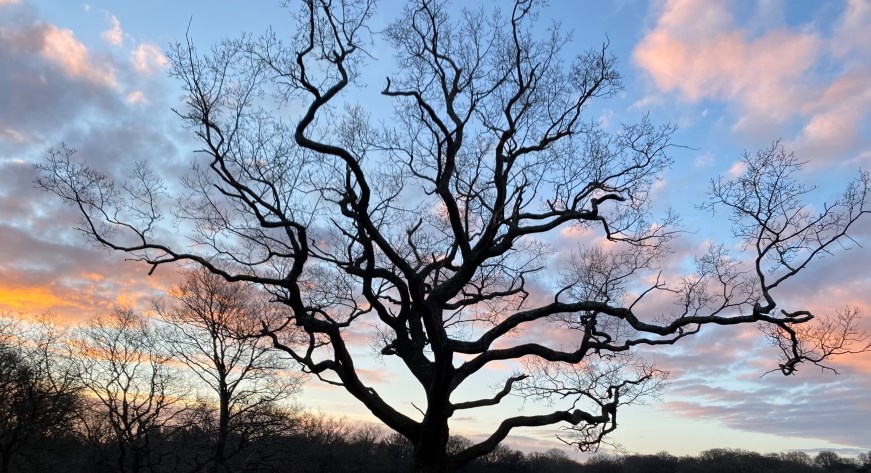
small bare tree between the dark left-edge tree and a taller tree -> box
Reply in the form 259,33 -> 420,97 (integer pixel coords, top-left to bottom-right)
74,307 -> 186,473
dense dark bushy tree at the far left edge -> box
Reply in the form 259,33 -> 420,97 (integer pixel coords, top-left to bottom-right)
0,313 -> 81,473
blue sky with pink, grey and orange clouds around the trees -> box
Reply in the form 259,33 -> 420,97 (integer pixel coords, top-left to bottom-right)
0,0 -> 871,460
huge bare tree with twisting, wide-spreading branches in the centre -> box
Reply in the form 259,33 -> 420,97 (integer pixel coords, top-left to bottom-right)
32,0 -> 871,471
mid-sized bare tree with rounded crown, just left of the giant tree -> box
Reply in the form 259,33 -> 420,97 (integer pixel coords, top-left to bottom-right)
155,270 -> 301,472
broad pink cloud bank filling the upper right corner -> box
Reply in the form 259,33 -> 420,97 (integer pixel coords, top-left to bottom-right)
633,0 -> 871,161
